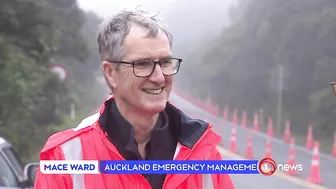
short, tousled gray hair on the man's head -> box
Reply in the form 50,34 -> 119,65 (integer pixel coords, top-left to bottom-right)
97,9 -> 173,61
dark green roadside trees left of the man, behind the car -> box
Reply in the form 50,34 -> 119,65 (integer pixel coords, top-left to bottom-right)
0,0 -> 105,160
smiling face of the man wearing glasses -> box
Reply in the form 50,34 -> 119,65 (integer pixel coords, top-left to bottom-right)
105,25 -> 173,114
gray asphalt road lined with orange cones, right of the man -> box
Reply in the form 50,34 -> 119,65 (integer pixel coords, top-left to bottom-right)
170,94 -> 336,189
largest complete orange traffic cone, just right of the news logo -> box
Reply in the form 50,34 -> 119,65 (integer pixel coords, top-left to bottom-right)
307,142 -> 323,184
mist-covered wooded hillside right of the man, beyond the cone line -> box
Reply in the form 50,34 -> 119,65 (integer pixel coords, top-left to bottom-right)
178,0 -> 336,145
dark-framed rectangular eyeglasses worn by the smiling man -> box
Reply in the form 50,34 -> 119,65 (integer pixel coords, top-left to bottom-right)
109,58 -> 182,77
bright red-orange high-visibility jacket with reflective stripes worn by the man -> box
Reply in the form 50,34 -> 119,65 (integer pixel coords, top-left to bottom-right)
34,97 -> 234,189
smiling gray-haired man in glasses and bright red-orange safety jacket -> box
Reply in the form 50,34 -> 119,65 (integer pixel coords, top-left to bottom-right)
35,10 -> 234,189
